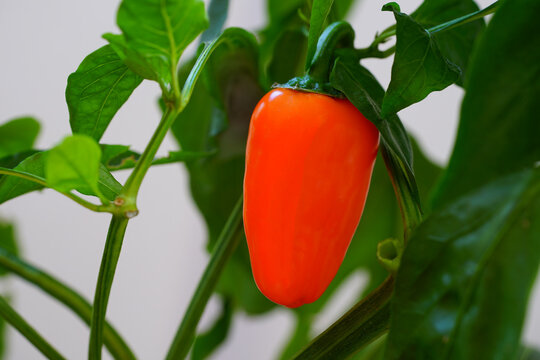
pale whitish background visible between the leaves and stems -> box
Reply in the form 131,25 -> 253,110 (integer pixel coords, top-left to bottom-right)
0,0 -> 540,360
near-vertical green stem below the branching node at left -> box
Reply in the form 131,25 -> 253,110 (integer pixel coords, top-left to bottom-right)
88,215 -> 129,360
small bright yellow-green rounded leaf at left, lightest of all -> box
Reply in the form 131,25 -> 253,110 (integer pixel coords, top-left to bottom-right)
45,135 -> 101,196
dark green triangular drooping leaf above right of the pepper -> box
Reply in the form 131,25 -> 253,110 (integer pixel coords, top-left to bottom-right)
382,4 -> 461,116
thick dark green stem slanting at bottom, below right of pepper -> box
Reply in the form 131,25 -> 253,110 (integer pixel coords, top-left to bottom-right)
294,276 -> 394,360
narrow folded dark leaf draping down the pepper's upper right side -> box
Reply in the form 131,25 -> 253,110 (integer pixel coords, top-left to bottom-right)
330,57 -> 420,207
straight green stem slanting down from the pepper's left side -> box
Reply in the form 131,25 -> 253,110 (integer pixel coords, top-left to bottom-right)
167,198 -> 243,360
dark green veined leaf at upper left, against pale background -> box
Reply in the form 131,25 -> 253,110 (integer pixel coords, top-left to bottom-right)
66,45 -> 142,141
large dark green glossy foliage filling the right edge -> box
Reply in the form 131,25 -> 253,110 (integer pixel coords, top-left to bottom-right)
387,0 -> 540,359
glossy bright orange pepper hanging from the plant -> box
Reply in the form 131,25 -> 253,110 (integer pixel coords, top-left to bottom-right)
244,89 -> 379,308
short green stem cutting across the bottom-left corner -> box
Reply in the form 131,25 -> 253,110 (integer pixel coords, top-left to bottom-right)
0,296 -> 65,360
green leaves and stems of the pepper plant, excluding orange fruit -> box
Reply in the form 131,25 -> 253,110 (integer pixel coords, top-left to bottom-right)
0,0 -> 540,360
